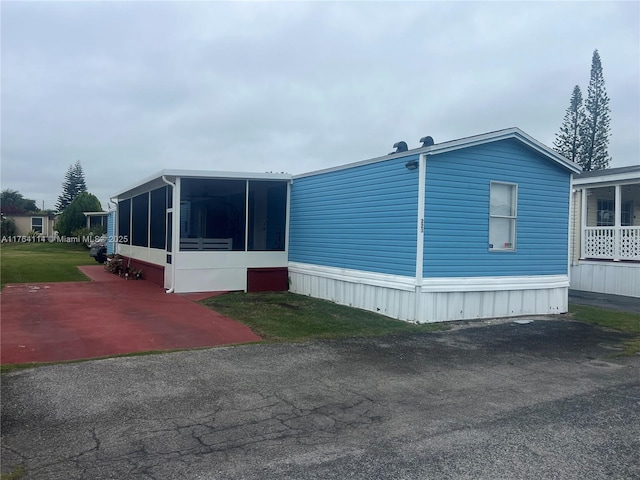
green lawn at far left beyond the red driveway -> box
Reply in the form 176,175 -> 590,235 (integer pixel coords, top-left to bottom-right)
0,243 -> 97,287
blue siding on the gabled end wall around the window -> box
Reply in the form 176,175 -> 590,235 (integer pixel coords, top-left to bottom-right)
423,140 -> 570,277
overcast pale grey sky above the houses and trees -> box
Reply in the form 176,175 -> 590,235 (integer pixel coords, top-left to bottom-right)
0,1 -> 640,208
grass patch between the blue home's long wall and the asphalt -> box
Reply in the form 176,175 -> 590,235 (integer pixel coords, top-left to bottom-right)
202,292 -> 449,342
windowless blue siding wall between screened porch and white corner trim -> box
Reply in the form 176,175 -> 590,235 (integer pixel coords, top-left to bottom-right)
289,155 -> 418,276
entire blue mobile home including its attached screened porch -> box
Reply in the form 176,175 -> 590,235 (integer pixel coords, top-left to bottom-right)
108,128 -> 580,322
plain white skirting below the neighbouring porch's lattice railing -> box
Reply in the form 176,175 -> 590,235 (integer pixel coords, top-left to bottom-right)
571,260 -> 640,297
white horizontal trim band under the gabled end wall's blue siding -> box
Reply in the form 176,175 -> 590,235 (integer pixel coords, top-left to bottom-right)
422,275 -> 569,292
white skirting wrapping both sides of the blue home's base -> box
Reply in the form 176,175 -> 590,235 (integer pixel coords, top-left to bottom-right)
289,262 -> 569,322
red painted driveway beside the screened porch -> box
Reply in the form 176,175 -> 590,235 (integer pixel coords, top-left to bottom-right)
0,265 -> 260,364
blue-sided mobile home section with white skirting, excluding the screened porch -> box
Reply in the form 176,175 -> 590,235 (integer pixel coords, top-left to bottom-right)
288,128 -> 580,322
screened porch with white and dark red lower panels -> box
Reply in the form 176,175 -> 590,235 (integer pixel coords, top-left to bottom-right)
107,170 -> 291,293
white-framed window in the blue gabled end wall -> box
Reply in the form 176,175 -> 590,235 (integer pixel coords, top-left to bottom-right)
489,182 -> 518,252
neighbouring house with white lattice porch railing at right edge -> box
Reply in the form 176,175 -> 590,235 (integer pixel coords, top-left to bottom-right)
571,165 -> 640,297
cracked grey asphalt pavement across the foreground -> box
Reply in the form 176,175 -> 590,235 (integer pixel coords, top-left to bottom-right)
1,317 -> 640,480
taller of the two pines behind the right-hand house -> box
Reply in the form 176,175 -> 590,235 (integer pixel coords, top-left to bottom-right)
580,50 -> 611,171
